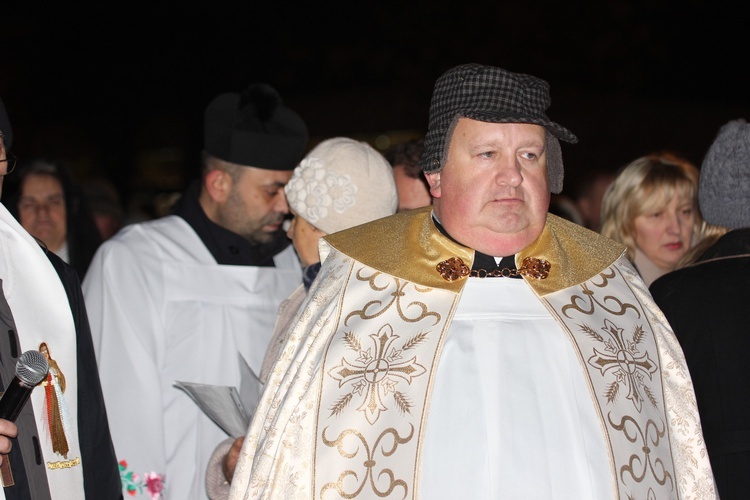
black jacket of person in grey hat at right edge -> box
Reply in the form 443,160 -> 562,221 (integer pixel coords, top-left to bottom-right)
650,229 -> 750,500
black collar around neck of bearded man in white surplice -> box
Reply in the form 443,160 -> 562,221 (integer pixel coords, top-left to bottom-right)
172,181 -> 290,267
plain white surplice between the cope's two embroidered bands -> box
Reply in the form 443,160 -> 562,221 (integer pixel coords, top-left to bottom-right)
420,278 -> 611,500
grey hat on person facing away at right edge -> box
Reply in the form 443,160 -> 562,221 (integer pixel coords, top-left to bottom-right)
698,119 -> 750,229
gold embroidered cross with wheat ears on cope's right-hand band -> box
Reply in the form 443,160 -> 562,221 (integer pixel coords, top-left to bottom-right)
579,319 -> 658,412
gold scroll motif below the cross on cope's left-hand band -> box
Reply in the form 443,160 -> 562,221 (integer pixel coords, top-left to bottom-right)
320,425 -> 414,498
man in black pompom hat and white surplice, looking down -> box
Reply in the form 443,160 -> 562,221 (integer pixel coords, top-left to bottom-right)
84,84 -> 308,500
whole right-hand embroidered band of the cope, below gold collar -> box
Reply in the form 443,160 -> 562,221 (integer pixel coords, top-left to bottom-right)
557,266 -> 676,499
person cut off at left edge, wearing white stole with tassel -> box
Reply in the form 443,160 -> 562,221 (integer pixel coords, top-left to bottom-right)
0,100 -> 122,499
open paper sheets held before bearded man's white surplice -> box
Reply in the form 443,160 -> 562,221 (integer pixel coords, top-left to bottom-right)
174,354 -> 263,438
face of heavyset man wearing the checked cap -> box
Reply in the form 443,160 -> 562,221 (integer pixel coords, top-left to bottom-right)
426,118 -> 550,257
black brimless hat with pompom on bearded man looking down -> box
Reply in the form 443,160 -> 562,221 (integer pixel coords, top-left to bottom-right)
204,83 -> 308,170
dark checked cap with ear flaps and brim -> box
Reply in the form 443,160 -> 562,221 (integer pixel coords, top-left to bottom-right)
419,64 -> 578,193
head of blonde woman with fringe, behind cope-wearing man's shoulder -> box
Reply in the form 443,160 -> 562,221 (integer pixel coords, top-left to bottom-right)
601,155 -> 702,286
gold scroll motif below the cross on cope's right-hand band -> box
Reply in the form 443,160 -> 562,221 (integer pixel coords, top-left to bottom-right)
607,414 -> 675,491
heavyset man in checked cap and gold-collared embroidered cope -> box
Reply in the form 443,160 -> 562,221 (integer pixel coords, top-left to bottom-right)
230,64 -> 714,500
